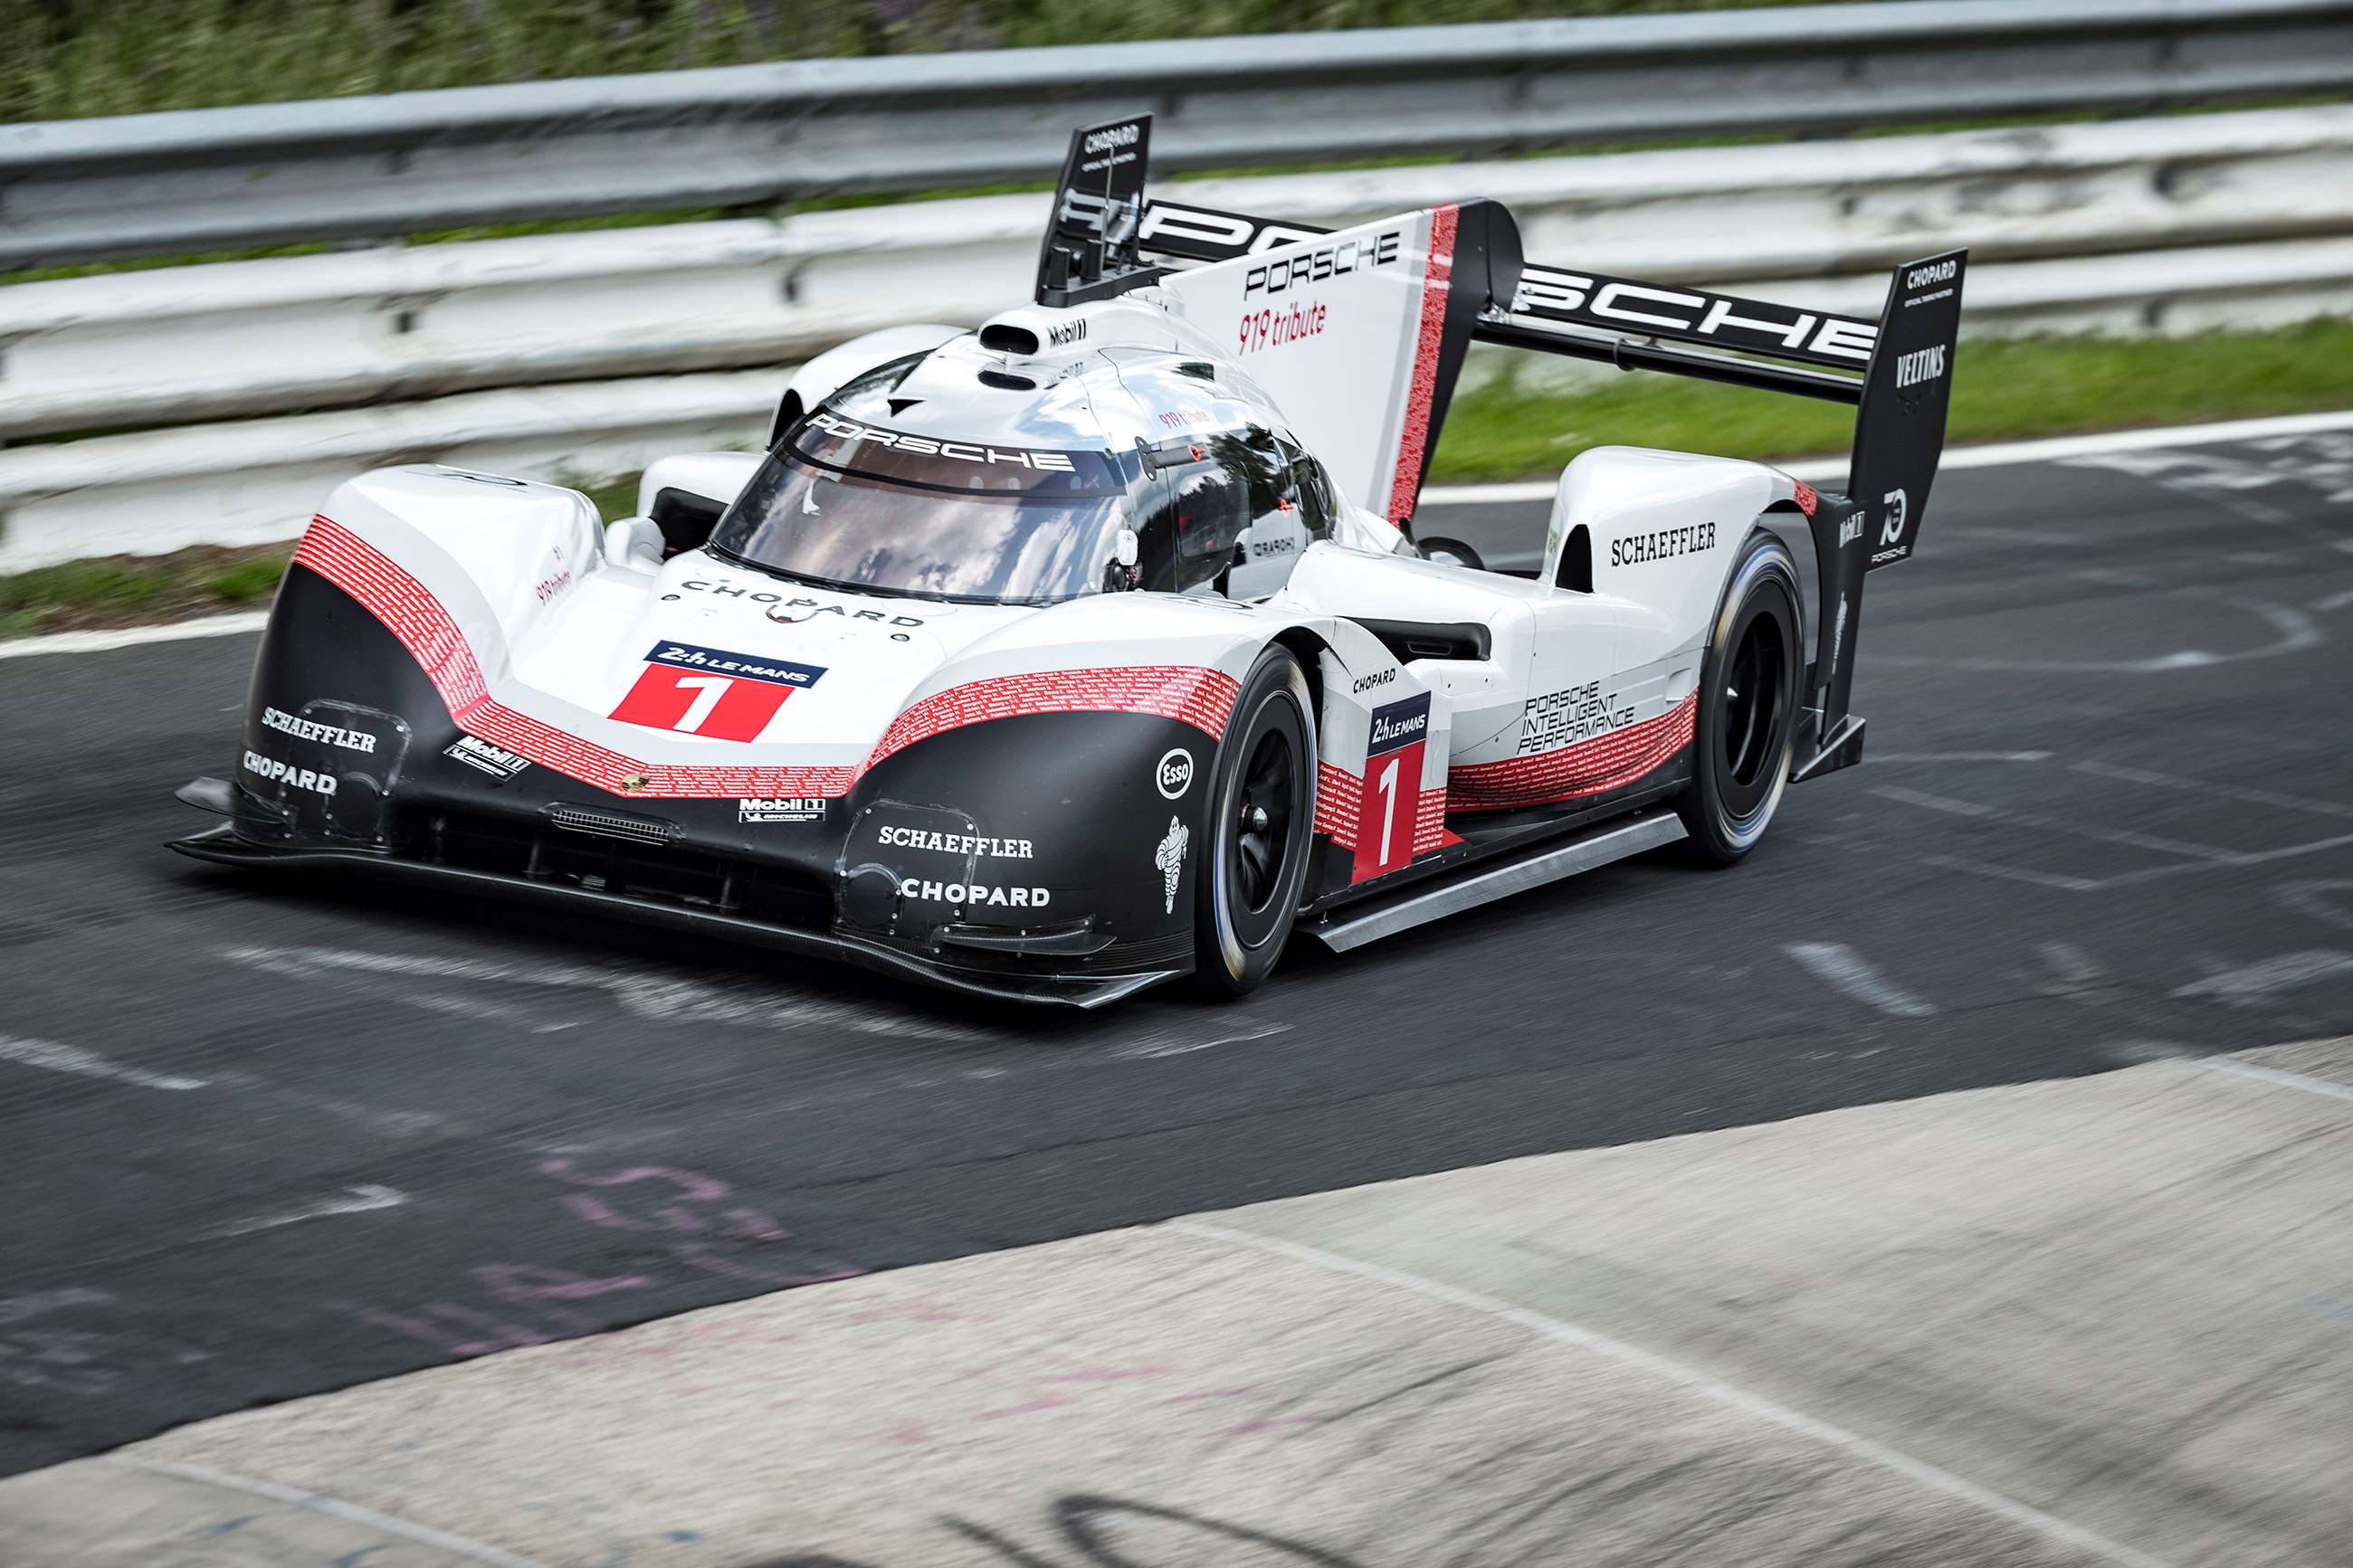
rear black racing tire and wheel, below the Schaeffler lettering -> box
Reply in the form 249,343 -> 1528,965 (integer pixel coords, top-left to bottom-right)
1675,529 -> 1805,865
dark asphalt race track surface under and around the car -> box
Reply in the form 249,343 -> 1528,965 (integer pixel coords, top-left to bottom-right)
0,435 -> 2353,1471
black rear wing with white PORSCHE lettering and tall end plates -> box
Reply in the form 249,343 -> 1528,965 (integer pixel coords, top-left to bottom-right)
1038,126 -> 1967,778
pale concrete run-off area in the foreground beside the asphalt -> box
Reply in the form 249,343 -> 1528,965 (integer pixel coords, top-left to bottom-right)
0,1039 -> 2353,1568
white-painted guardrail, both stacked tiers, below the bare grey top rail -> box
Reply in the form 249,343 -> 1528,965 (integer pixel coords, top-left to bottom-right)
14,106 -> 2353,571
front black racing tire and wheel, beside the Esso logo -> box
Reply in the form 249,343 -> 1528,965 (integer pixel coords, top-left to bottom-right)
1193,647 -> 1315,997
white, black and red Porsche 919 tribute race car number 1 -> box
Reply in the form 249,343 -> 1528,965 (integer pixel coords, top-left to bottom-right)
174,118 -> 1965,1006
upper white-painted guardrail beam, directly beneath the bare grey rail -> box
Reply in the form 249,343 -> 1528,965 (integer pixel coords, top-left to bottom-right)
0,106 -> 2353,442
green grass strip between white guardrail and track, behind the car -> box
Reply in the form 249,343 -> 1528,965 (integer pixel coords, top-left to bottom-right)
0,322 -> 2353,637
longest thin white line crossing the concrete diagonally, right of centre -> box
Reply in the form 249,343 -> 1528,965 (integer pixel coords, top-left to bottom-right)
1167,1220 -> 2167,1568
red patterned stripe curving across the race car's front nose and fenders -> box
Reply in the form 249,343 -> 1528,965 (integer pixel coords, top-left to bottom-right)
294,518 -> 1240,799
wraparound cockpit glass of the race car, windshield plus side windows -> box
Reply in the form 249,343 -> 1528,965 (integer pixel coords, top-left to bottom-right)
710,355 -> 1337,604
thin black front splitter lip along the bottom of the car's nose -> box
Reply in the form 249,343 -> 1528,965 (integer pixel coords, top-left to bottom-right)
169,822 -> 1184,1009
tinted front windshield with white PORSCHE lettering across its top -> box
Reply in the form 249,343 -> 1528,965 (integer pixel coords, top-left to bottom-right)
710,409 -> 1127,604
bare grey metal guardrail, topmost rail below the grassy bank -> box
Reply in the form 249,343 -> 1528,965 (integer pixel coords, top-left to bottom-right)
0,0 -> 2353,268
